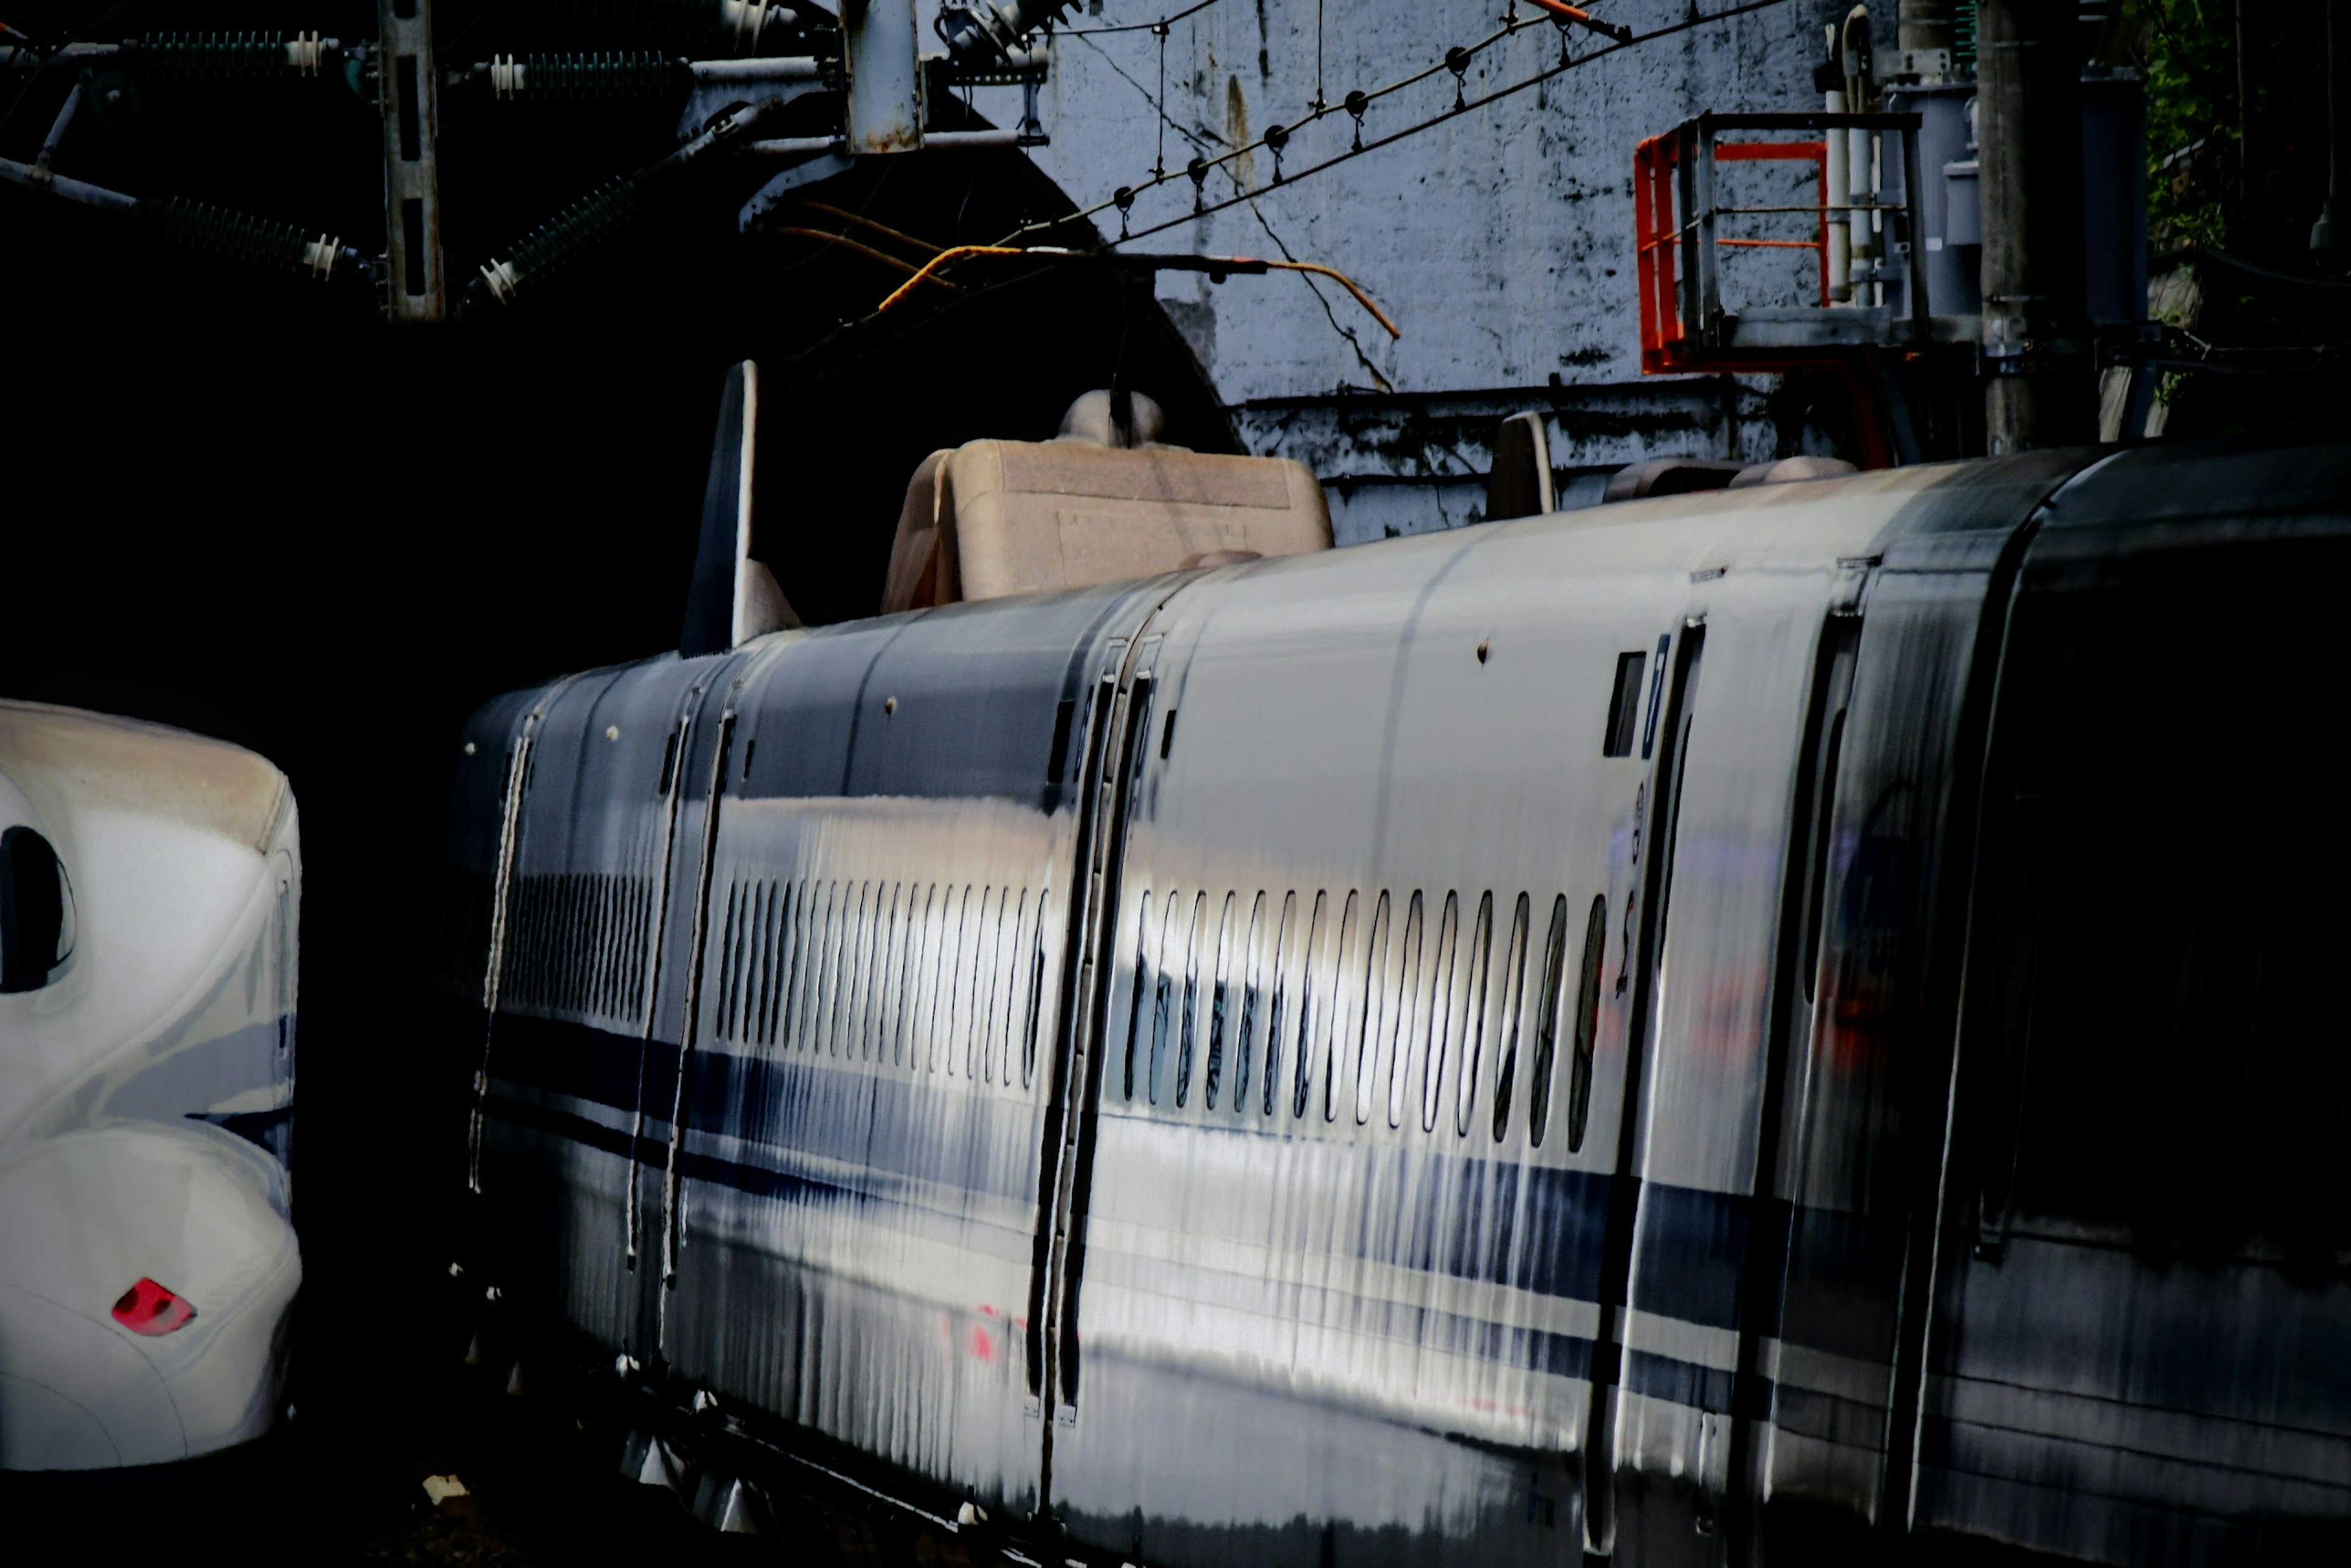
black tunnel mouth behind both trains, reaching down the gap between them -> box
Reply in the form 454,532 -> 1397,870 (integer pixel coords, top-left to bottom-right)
0,2 -> 1232,1561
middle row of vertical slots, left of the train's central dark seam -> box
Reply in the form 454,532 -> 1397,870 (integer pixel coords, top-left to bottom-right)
713,879 -> 1051,1086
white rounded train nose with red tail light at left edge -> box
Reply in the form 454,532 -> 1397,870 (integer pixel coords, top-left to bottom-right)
0,700 -> 301,1472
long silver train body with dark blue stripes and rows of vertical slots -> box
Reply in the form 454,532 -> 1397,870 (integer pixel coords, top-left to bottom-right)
435,432 -> 2351,1566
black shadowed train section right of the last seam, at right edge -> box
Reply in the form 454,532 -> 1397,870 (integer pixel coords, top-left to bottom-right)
1911,524 -> 2351,1561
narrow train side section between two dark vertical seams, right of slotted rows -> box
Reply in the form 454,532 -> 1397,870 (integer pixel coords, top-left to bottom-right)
1582,564 -> 1864,1566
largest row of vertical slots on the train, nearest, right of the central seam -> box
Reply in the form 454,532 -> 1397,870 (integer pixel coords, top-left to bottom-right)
1122,888 -> 1608,1152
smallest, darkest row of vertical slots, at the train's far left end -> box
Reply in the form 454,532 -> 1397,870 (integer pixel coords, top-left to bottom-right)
498,872 -> 654,1018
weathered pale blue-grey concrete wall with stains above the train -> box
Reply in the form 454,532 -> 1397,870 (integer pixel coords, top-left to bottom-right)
980,0 -> 1892,514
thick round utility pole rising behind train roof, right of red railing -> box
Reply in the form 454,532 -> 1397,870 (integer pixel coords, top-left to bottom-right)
1975,0 -> 2097,456
